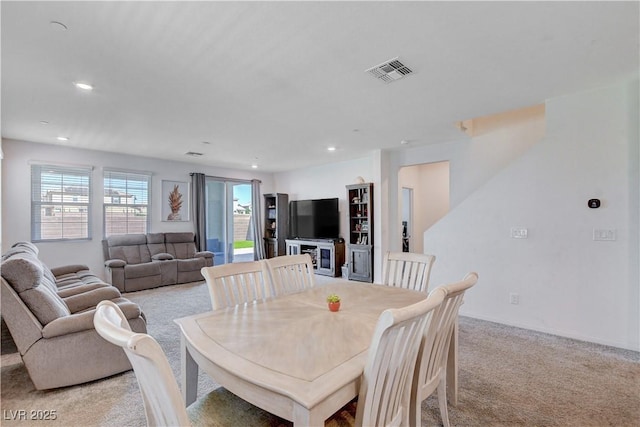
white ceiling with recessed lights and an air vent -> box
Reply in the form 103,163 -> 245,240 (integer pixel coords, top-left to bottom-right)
0,1 -> 639,171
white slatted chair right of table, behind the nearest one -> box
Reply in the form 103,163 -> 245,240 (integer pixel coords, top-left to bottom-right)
410,273 -> 478,427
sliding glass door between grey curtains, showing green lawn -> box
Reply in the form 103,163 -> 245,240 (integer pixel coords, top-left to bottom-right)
205,177 -> 254,265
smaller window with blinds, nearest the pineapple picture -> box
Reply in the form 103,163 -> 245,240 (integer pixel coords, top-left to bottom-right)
104,170 -> 151,237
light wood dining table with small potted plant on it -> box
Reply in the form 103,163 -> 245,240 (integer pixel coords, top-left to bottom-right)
175,279 -> 427,426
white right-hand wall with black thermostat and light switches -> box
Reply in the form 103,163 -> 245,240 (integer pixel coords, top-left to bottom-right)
424,81 -> 640,350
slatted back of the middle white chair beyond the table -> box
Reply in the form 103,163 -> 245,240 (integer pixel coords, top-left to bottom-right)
266,254 -> 315,295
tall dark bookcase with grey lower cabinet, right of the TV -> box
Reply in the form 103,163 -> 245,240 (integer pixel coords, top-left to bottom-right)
347,183 -> 373,282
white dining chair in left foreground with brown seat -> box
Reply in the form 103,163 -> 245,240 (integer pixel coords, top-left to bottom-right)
93,300 -> 290,427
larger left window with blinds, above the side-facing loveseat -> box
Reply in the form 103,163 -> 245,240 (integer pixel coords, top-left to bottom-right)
31,165 -> 91,242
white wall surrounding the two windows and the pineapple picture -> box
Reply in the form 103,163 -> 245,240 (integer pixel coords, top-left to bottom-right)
0,140 -> 274,278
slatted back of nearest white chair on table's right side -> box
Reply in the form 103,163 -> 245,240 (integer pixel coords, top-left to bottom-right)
355,290 -> 445,426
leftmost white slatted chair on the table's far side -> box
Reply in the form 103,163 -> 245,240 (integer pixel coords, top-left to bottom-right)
200,260 -> 273,310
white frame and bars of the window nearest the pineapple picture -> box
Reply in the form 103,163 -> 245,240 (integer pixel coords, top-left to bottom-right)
102,168 -> 152,238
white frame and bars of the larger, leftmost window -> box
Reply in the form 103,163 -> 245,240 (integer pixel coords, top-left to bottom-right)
30,163 -> 93,242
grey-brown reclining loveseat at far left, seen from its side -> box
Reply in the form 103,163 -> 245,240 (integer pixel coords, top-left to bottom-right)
0,242 -> 147,390
